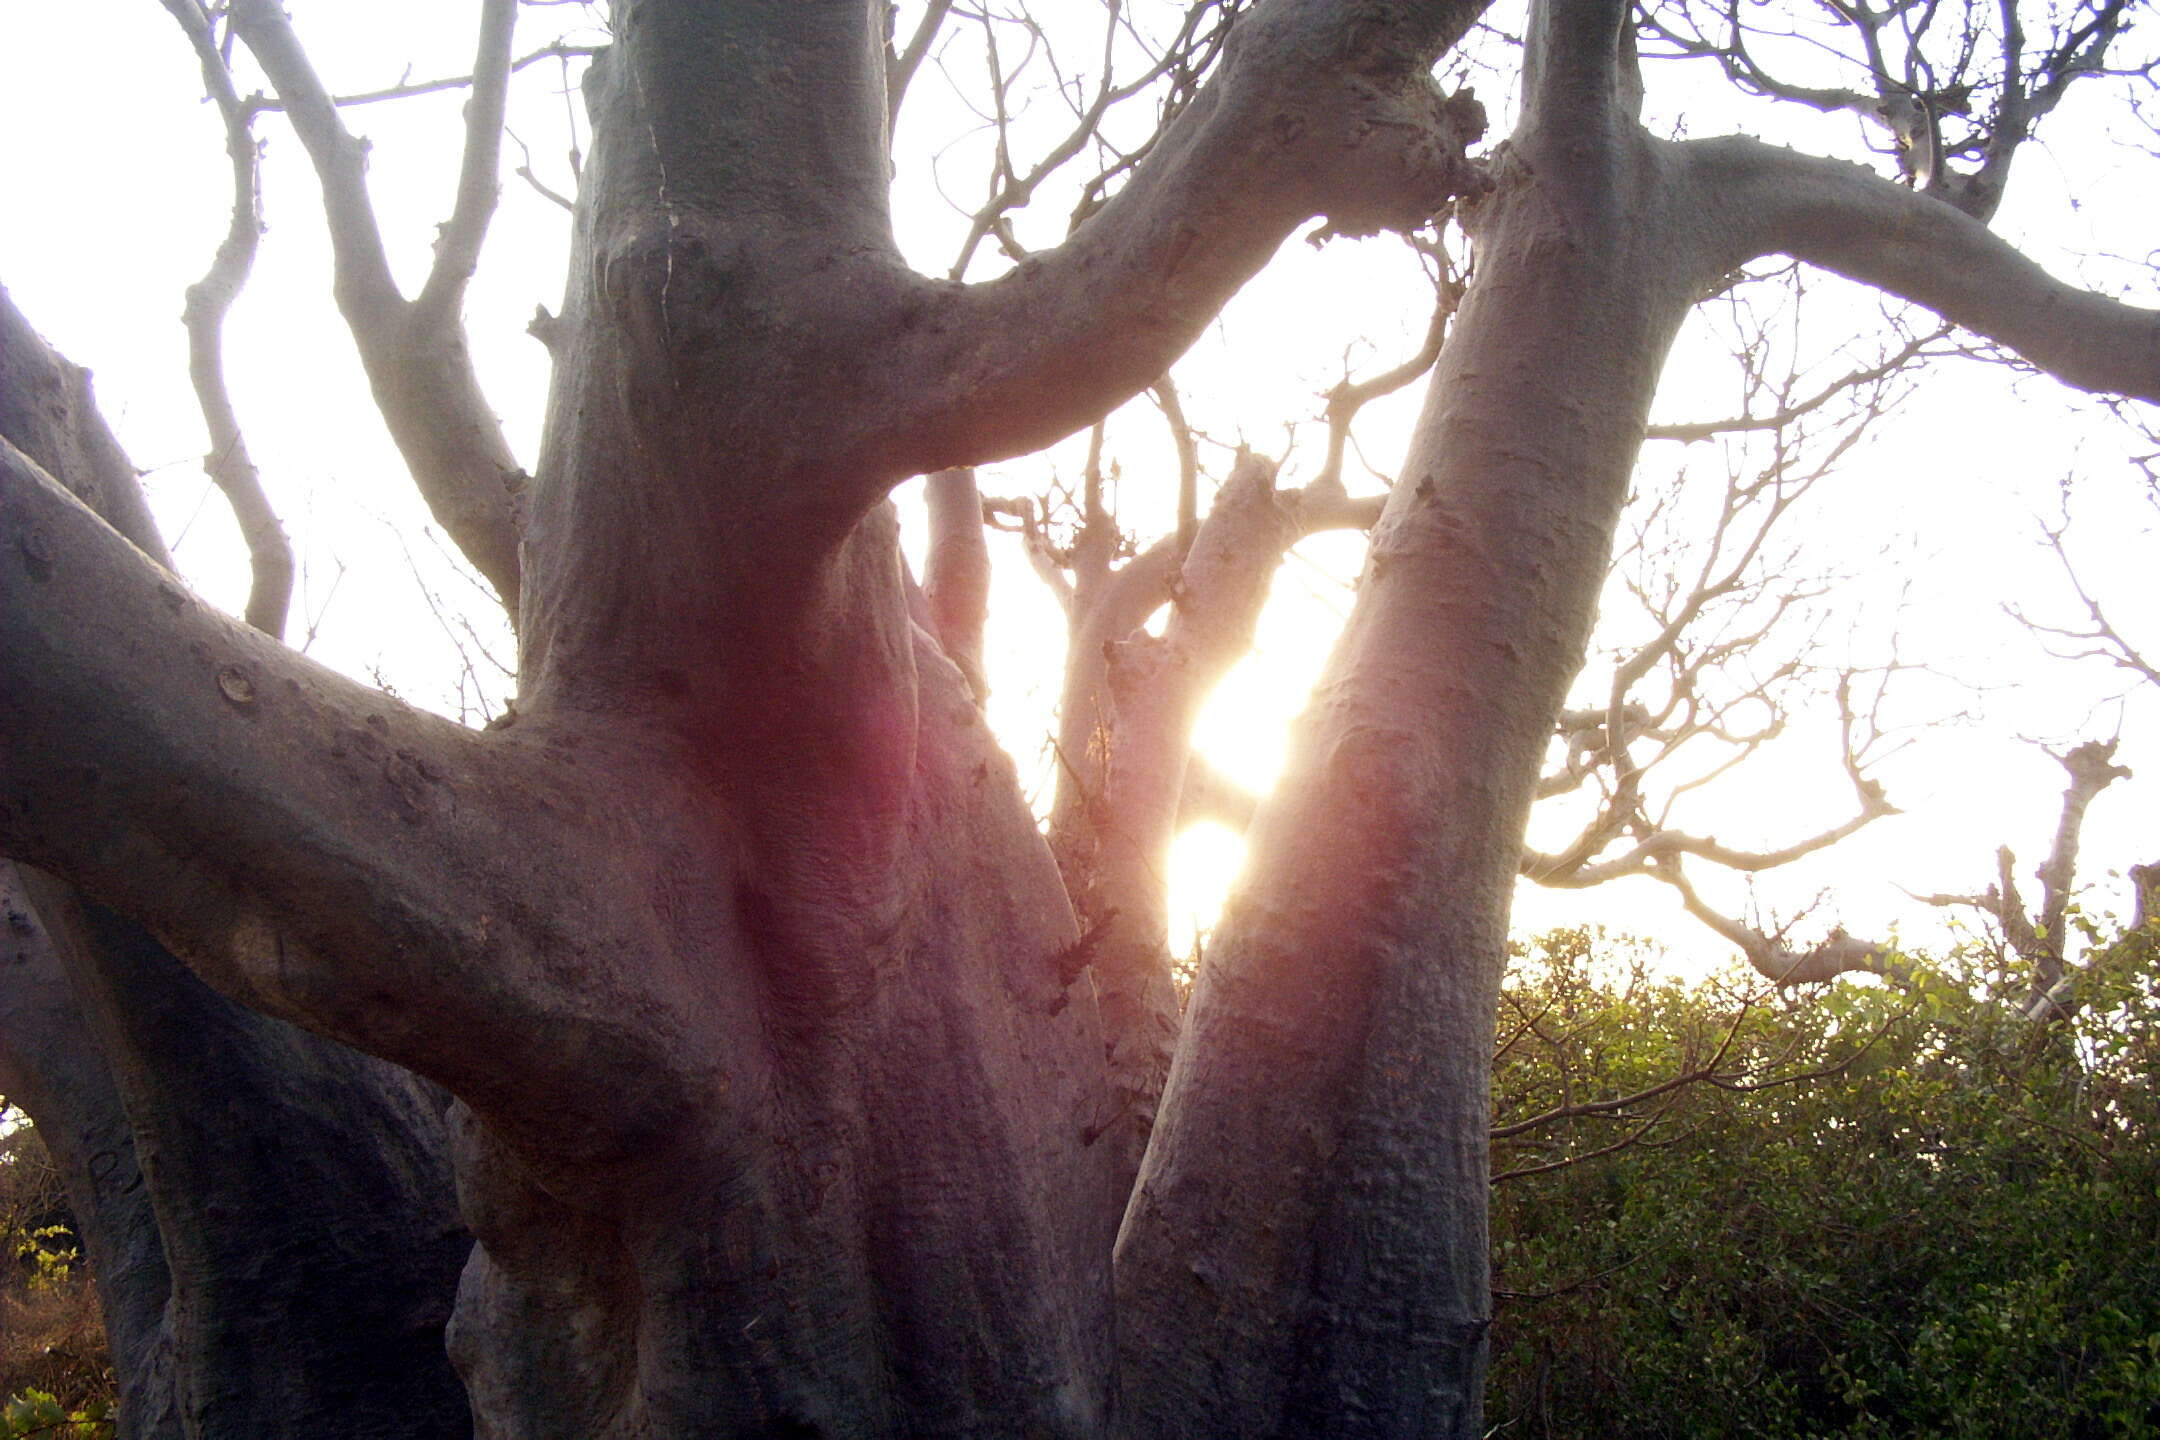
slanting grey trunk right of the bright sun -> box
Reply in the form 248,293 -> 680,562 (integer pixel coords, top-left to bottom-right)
1117,4 -> 1700,1438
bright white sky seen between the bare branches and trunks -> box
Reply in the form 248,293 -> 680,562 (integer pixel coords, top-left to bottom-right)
0,0 -> 2160,980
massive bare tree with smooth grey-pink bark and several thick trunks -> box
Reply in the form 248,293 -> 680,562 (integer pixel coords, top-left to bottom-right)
0,0 -> 2160,1438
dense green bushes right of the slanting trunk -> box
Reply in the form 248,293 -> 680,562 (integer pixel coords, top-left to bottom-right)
1488,933 -> 2160,1440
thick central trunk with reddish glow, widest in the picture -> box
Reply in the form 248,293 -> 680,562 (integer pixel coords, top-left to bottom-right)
440,0 -> 1119,1440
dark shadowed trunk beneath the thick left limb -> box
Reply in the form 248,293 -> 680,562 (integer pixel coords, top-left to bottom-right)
28,877 -> 471,1440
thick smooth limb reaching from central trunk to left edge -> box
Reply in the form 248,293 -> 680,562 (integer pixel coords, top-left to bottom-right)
0,443 -> 626,1123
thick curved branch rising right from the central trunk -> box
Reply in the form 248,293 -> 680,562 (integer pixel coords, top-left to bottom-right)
868,0 -> 1484,473
